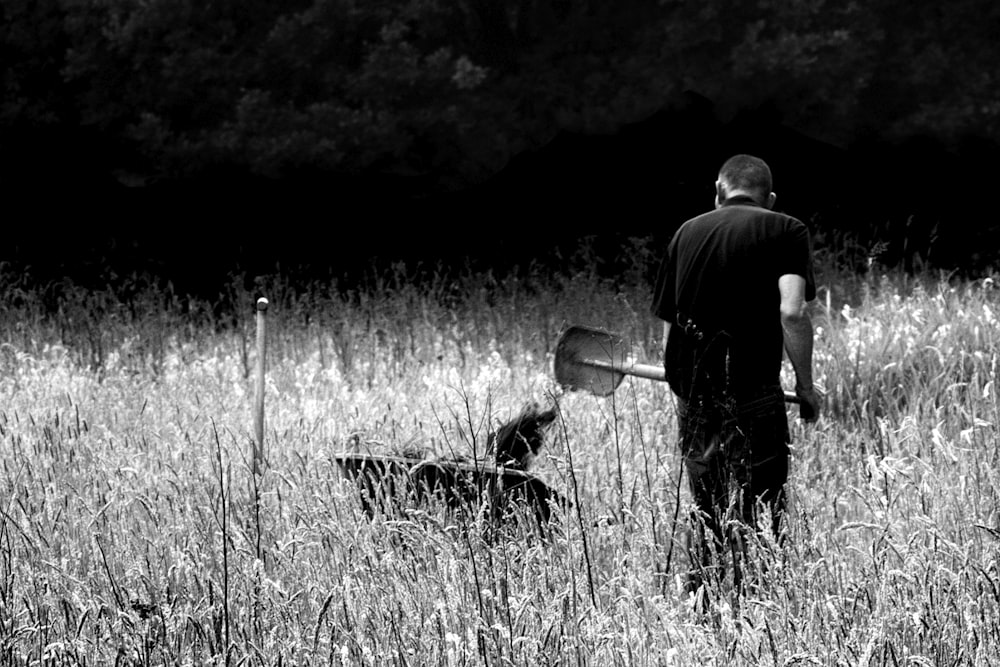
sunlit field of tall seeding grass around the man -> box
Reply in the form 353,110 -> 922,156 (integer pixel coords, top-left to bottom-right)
0,252 -> 1000,665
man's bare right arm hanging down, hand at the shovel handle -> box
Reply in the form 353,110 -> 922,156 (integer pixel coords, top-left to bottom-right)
778,274 -> 820,421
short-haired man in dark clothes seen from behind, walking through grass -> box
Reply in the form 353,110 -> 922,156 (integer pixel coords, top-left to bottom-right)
652,155 -> 820,590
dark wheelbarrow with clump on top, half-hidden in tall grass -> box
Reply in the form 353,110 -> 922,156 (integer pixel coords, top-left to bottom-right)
334,404 -> 568,527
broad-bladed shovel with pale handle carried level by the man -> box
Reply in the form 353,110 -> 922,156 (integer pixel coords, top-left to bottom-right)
555,324 -> 801,403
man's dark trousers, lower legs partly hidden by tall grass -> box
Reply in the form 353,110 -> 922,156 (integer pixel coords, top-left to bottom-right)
678,387 -> 789,589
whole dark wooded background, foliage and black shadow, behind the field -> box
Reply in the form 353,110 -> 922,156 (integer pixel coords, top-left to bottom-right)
0,0 -> 1000,288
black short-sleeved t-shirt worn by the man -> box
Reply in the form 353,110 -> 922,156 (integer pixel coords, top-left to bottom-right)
651,197 -> 816,388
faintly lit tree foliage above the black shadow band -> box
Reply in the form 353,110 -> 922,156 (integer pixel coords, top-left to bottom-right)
0,0 -> 1000,190
